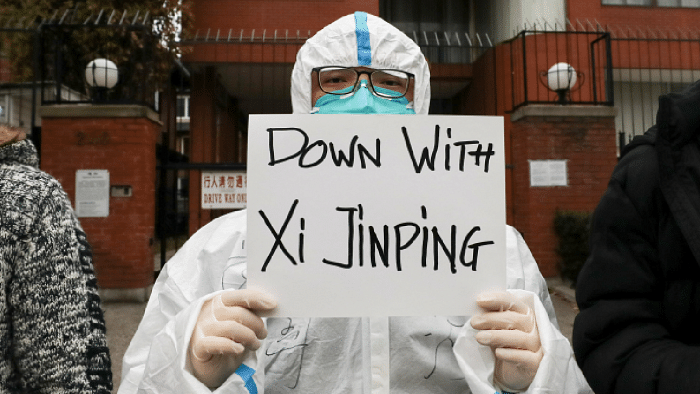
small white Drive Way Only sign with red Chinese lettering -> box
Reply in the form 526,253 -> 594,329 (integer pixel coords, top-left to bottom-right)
202,171 -> 248,209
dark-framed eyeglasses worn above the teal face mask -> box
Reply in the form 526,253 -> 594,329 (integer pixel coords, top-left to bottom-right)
312,66 -> 414,98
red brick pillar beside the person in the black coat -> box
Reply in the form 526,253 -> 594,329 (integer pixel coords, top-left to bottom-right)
511,105 -> 617,277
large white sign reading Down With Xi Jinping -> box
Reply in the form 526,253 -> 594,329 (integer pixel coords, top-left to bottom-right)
247,115 -> 506,317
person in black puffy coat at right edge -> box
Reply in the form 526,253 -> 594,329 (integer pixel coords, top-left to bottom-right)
573,81 -> 700,394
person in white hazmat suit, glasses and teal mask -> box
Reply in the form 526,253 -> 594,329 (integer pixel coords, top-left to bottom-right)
119,12 -> 590,394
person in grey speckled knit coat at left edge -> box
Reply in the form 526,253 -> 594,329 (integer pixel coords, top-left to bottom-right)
0,125 -> 112,394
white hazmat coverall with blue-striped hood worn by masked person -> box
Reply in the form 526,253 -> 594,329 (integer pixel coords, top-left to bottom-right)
119,15 -> 590,394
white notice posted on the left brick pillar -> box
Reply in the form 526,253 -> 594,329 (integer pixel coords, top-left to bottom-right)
75,170 -> 109,218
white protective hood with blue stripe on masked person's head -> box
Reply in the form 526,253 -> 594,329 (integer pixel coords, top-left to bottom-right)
292,12 -> 430,115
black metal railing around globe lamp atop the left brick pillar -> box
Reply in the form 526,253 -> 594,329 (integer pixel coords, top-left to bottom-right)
38,12 -> 159,108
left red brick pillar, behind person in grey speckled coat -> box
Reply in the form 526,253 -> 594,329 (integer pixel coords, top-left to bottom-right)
40,105 -> 161,300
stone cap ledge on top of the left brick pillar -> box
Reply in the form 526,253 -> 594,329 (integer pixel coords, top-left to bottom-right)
39,104 -> 162,124
